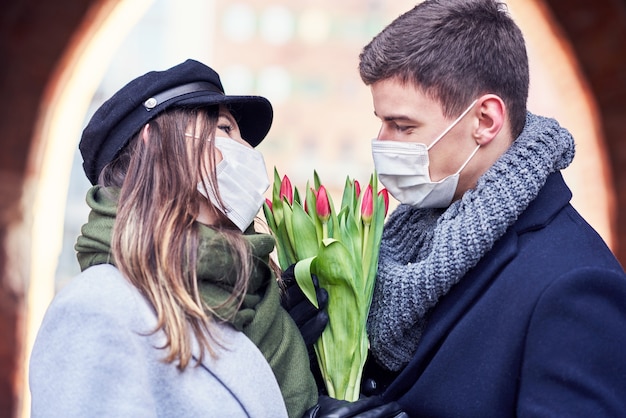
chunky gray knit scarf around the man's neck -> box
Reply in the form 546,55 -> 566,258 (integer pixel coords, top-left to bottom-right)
368,113 -> 574,371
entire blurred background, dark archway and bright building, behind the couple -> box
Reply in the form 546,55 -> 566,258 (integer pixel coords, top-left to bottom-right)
0,0 -> 626,417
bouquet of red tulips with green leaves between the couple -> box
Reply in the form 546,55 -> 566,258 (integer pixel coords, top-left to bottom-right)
263,169 -> 389,401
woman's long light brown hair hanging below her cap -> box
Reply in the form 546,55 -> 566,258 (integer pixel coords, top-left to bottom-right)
100,107 -> 252,369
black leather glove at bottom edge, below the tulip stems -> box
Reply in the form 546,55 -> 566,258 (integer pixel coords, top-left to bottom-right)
303,396 -> 409,418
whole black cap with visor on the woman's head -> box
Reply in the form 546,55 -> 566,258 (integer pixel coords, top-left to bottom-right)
78,59 -> 273,184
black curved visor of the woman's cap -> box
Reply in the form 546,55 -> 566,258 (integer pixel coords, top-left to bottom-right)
176,92 -> 274,147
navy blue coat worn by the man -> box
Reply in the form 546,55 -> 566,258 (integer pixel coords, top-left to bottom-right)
384,173 -> 626,418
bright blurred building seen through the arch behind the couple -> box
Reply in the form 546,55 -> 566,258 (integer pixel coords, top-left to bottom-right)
54,0 -> 414,289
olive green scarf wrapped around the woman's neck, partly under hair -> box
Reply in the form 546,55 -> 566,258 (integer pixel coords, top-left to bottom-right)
75,186 -> 317,417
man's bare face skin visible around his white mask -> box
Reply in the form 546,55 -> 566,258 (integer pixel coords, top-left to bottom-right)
371,78 -> 476,181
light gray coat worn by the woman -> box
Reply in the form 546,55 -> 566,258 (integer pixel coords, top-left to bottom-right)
30,265 -> 287,418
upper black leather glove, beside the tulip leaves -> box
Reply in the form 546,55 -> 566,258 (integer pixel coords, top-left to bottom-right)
280,265 -> 328,348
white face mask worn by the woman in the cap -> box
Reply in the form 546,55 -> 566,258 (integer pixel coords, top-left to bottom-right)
198,137 -> 270,232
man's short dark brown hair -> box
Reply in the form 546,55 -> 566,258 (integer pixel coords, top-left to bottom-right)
359,0 -> 529,138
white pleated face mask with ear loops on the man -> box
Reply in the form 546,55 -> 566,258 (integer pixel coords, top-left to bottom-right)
372,100 -> 480,208
